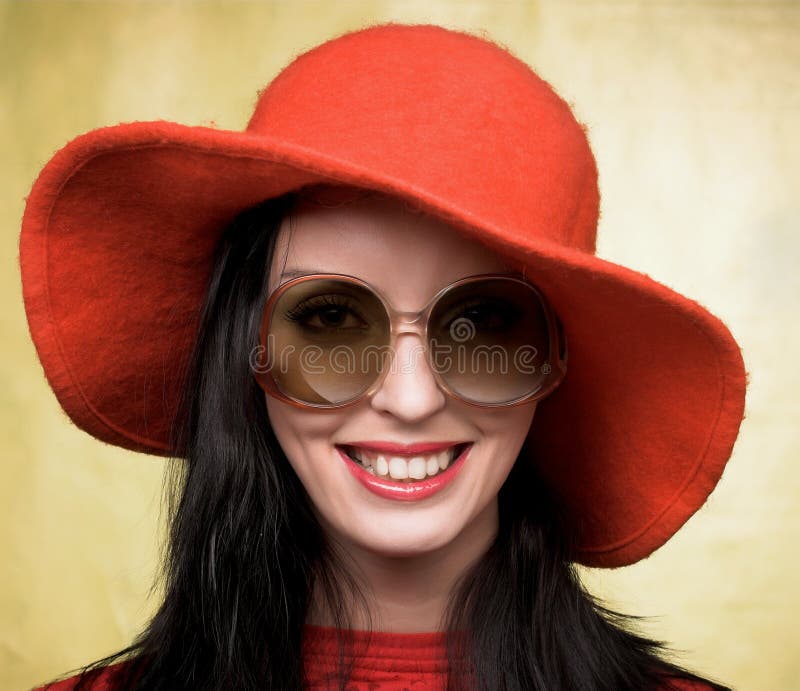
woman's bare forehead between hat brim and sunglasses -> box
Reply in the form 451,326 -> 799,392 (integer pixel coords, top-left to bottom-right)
270,194 -> 511,294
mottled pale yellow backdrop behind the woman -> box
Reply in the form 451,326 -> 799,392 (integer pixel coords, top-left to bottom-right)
0,0 -> 800,691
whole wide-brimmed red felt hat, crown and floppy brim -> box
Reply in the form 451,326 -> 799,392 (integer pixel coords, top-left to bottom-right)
15,23 -> 746,567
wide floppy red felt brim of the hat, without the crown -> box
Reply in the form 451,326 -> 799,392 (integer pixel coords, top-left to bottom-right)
20,122 -> 746,567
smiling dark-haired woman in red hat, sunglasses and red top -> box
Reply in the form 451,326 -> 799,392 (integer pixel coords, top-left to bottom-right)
25,24 -> 745,689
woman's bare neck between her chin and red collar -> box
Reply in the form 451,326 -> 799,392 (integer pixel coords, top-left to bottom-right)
308,498 -> 498,633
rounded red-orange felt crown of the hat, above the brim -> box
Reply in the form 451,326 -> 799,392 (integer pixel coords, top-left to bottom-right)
247,23 -> 599,252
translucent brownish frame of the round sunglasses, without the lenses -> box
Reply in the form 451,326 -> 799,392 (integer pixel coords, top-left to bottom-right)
255,273 -> 567,410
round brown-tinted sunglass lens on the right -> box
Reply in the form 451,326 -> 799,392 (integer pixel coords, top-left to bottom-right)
428,278 -> 550,404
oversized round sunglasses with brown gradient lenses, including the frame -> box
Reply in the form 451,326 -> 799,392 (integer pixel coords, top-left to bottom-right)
250,274 -> 567,408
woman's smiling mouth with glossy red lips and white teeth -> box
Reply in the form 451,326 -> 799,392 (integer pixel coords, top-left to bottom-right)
336,442 -> 473,501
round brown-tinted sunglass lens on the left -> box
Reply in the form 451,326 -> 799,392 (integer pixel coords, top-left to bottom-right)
265,279 -> 390,406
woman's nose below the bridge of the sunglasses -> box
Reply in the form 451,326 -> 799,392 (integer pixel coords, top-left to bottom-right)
371,334 -> 447,422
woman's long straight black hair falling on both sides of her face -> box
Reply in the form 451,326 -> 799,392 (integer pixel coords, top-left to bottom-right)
42,193 -> 730,691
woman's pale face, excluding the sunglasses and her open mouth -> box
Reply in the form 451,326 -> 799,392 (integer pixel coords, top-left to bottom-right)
266,189 -> 536,556
